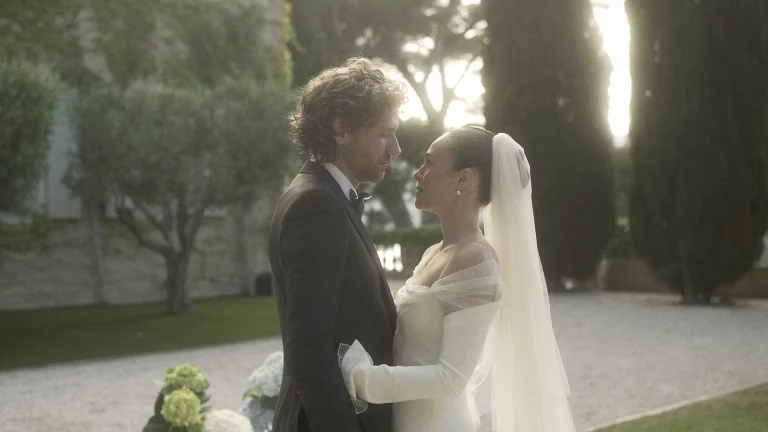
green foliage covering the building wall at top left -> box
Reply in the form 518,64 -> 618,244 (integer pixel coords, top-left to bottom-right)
0,0 -> 292,88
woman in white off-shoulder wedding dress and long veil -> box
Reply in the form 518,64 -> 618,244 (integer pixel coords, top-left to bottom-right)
339,126 -> 575,432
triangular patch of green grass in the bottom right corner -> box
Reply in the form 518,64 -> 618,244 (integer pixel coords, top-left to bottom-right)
599,385 -> 768,432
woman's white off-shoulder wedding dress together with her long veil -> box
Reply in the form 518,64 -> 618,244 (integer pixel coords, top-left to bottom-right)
339,133 -> 576,432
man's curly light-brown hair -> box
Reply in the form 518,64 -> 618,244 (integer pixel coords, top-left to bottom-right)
290,58 -> 406,163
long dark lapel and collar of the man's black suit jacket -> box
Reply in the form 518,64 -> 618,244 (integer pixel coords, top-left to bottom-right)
300,161 -> 397,327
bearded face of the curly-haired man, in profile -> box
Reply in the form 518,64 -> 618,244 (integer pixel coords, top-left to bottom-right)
336,108 -> 400,186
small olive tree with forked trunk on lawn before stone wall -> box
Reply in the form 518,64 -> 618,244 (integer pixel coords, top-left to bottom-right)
68,82 -> 216,313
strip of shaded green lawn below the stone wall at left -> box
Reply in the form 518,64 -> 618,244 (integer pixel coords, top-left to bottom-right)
0,297 -> 280,370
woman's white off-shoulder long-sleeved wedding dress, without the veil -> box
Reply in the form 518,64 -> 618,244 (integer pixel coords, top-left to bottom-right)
340,246 -> 502,432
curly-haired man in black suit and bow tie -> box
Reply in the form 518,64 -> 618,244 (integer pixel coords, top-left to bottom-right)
269,59 -> 405,432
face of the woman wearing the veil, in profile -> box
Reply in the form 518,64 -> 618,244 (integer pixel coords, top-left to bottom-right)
413,137 -> 460,213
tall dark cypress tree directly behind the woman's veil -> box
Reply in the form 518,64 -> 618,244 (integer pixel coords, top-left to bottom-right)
483,0 -> 615,286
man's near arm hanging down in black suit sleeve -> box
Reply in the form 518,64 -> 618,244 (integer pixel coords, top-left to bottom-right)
281,190 -> 359,432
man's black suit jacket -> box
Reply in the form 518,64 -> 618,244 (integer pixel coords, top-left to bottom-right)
269,161 -> 397,432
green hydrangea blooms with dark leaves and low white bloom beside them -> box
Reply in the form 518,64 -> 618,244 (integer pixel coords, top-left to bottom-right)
142,363 -> 253,432
